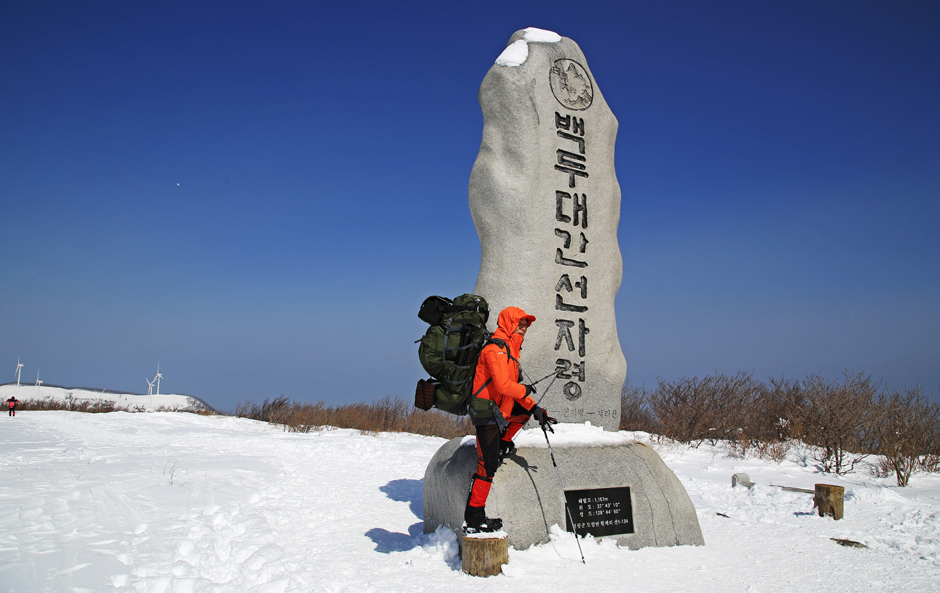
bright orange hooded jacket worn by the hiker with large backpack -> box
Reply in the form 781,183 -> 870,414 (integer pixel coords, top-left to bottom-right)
473,307 -> 535,418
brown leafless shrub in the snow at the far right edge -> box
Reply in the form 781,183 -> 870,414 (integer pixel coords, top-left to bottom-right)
876,387 -> 940,486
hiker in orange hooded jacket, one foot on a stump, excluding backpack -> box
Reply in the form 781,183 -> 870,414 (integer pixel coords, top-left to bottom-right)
464,307 -> 558,532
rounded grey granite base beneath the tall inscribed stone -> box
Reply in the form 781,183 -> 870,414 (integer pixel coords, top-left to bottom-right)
424,424 -> 705,550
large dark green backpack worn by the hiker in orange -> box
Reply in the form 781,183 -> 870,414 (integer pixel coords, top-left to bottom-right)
415,294 -> 490,416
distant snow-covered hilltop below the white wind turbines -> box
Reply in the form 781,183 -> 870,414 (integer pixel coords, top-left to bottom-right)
0,383 -> 212,412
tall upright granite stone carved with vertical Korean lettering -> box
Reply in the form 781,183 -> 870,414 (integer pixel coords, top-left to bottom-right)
469,28 -> 627,430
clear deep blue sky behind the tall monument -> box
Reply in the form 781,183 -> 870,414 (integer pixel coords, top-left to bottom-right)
0,0 -> 940,409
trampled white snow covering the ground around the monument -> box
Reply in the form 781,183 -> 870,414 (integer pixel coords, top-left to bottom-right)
0,412 -> 940,593
